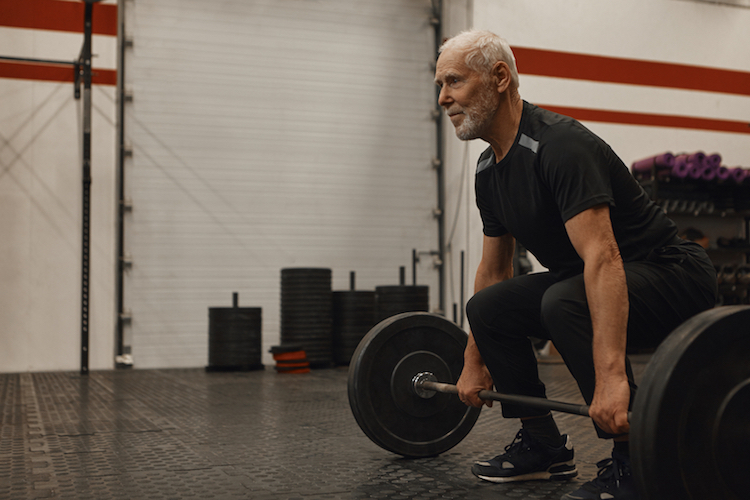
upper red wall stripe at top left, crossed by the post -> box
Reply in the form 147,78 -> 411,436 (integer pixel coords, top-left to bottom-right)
0,0 -> 117,36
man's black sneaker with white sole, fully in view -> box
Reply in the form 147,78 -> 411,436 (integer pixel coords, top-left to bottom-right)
471,429 -> 578,483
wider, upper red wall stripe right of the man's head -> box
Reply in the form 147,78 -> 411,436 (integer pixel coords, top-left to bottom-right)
513,47 -> 750,95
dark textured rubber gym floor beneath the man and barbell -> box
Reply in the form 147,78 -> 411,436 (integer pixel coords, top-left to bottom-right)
0,360 -> 645,500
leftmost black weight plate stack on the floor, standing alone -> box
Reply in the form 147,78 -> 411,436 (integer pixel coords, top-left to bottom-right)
206,307 -> 263,371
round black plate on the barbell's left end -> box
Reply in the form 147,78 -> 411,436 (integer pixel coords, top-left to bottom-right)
348,312 -> 480,458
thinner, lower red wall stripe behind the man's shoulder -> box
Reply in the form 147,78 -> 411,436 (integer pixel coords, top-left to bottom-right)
540,104 -> 750,134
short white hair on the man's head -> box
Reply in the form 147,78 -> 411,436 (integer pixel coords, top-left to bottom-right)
438,29 -> 520,88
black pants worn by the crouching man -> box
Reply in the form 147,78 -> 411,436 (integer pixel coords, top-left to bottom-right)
466,240 -> 717,438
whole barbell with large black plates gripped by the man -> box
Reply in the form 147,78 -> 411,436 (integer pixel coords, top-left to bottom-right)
348,306 -> 750,500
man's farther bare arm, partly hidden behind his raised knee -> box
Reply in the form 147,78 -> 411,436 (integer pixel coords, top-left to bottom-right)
456,234 -> 515,408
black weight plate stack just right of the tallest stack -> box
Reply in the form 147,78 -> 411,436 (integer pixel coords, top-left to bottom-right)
333,290 -> 377,365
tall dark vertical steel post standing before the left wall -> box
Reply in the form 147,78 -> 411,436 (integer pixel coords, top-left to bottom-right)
80,1 -> 94,375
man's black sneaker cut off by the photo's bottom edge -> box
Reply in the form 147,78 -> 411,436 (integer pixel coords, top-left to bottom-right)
562,452 -> 638,500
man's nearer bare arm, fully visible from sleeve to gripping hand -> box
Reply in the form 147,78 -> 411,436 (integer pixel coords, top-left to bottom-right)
565,205 -> 630,434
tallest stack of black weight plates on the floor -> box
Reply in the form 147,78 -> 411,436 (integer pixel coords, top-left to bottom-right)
281,268 -> 333,368
